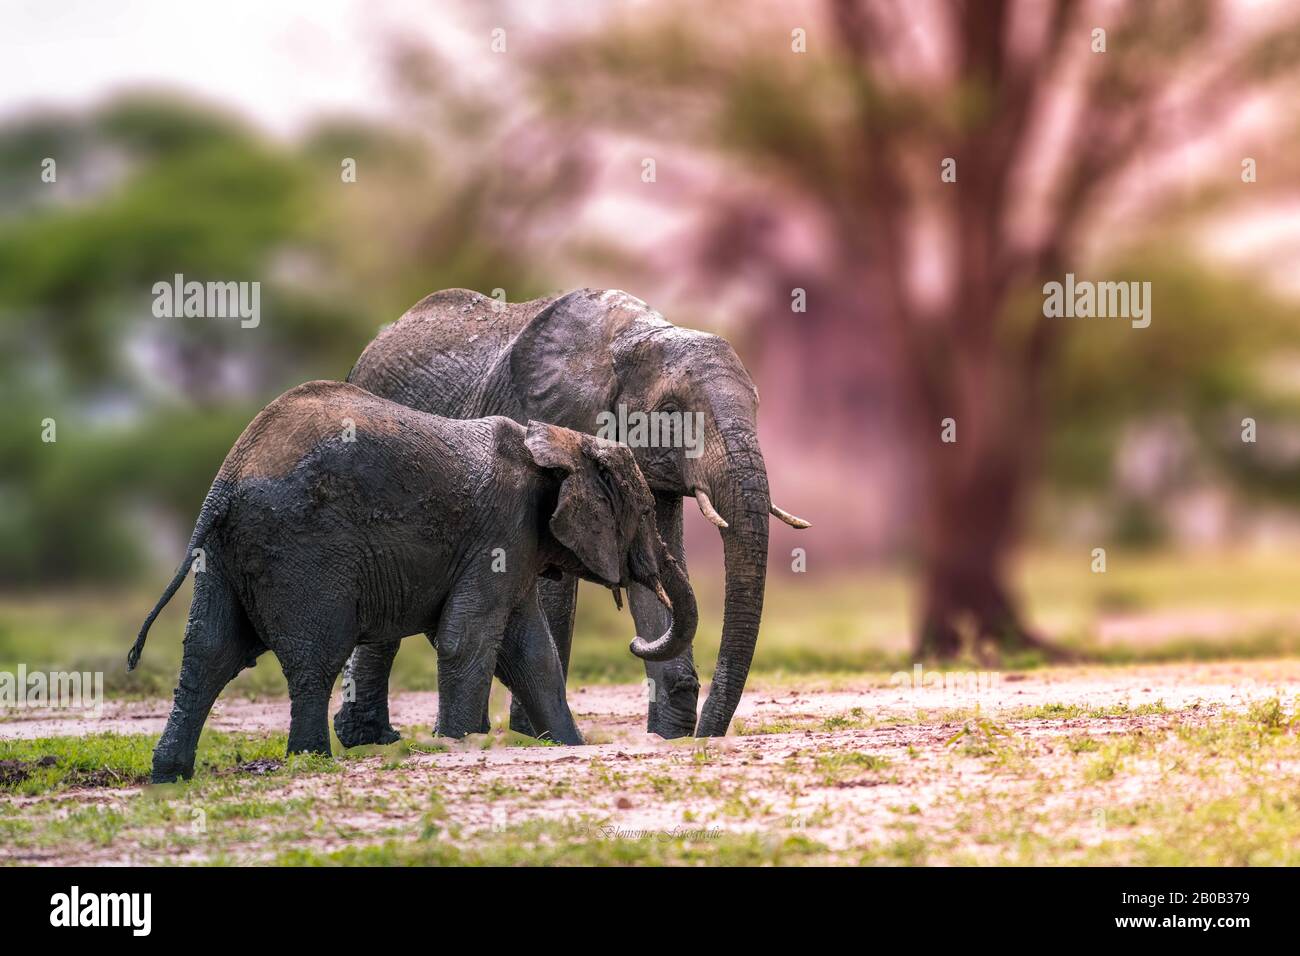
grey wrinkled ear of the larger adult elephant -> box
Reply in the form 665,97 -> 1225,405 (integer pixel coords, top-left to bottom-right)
510,289 -> 618,432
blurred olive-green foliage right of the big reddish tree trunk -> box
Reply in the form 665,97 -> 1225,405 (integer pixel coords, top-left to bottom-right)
1048,250 -> 1300,509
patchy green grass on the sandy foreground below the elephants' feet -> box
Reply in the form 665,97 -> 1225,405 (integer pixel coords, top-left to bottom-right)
0,698 -> 1300,866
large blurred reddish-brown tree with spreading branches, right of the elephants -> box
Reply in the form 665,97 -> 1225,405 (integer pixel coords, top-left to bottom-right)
493,0 -> 1300,657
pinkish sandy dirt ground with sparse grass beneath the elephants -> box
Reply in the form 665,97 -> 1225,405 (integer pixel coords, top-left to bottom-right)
0,661 -> 1300,864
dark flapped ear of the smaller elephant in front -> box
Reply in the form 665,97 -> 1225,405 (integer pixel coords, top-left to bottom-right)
524,421 -> 623,584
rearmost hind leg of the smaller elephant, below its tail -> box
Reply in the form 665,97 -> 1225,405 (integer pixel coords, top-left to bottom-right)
151,568 -> 265,783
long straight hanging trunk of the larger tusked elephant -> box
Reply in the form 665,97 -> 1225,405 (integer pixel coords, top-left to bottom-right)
696,429 -> 772,737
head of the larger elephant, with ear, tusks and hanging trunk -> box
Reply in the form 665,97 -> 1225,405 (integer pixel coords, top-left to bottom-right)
498,289 -> 809,736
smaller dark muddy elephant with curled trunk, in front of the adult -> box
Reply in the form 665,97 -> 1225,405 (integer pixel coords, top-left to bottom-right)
127,381 -> 697,783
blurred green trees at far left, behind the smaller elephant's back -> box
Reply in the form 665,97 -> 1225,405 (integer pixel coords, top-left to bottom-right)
0,94 -> 538,585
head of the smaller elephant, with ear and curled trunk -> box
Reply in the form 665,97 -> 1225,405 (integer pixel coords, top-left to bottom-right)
524,421 -> 697,661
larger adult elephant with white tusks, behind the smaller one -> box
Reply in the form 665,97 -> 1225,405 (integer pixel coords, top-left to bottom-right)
334,289 -> 809,747
